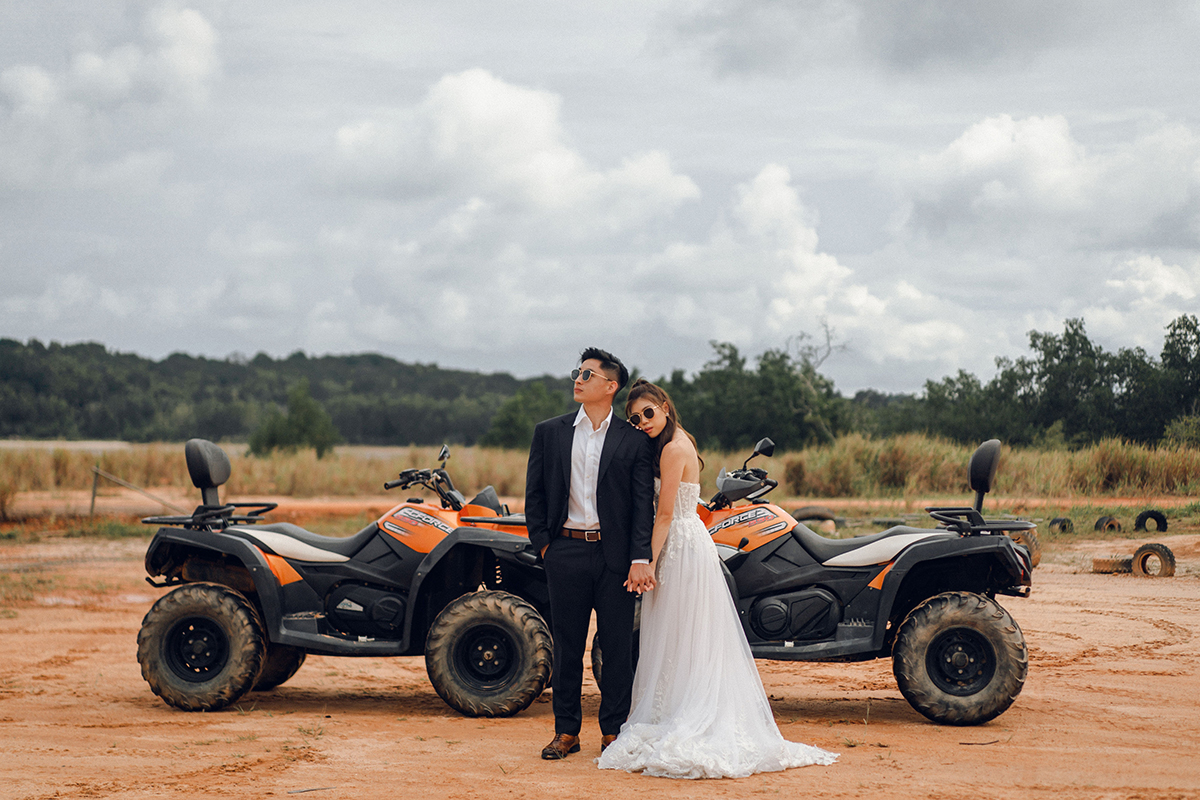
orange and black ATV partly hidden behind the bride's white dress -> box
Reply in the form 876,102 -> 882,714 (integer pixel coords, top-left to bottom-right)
592,439 -> 1034,726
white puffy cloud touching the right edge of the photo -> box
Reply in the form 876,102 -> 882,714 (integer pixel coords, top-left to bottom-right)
901,115 -> 1200,254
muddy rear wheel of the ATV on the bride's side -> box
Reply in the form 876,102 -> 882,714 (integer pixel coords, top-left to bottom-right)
892,591 -> 1030,726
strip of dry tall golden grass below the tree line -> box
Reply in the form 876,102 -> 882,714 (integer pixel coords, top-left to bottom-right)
0,434 -> 1200,503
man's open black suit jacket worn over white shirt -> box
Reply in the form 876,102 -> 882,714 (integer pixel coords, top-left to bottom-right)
526,411 -> 654,575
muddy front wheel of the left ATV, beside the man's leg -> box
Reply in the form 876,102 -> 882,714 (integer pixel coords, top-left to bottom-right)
425,591 -> 554,717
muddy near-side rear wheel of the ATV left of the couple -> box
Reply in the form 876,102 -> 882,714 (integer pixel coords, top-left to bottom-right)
138,583 -> 266,711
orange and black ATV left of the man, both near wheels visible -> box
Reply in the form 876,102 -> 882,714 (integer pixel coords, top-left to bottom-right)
138,439 -> 553,716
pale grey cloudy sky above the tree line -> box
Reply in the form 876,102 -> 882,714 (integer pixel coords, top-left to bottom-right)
0,0 -> 1200,393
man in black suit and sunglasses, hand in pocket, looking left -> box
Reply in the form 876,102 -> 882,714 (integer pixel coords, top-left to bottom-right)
526,348 -> 654,759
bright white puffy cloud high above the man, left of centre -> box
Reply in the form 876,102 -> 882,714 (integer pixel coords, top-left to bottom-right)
332,68 -> 700,234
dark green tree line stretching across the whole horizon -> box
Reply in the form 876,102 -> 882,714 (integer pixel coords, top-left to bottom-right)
0,314 -> 1200,452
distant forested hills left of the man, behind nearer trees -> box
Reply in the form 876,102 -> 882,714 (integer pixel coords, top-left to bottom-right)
0,338 -> 570,445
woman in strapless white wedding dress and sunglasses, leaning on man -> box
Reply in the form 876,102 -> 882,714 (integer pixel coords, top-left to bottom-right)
598,380 -> 838,778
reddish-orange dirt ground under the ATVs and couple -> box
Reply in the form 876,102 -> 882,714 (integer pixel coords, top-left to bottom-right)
0,491 -> 1200,800
